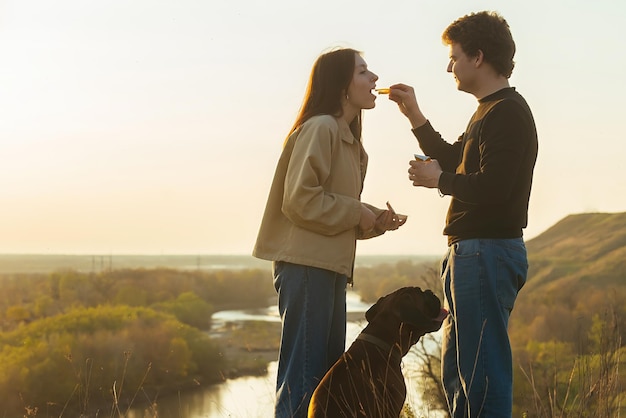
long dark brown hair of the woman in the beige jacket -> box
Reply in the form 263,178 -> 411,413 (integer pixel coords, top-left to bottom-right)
287,48 -> 361,141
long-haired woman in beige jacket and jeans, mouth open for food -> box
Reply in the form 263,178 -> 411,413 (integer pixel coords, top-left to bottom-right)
253,49 -> 406,417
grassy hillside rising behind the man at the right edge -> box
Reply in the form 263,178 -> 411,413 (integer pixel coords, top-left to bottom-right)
510,212 -> 626,349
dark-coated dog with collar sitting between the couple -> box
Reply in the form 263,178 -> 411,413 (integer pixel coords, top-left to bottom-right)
308,287 -> 448,418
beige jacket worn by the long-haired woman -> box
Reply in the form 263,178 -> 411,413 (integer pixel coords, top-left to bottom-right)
252,115 -> 383,281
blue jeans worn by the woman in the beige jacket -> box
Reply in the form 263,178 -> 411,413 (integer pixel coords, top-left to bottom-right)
273,261 -> 348,418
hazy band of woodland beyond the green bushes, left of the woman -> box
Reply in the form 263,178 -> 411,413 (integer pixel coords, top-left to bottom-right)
0,269 -> 275,331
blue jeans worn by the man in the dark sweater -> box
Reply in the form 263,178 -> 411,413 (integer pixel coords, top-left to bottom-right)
441,238 -> 528,418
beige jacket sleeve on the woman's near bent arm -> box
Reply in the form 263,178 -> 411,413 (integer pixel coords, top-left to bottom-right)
282,123 -> 361,235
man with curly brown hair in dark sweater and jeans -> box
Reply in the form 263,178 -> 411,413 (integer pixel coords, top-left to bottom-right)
389,12 -> 537,418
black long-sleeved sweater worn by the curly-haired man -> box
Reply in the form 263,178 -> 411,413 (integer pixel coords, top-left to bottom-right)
413,87 -> 537,244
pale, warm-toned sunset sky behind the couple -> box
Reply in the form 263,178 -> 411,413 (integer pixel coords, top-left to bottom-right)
0,0 -> 626,255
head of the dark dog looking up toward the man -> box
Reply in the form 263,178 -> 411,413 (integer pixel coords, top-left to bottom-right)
365,287 -> 448,353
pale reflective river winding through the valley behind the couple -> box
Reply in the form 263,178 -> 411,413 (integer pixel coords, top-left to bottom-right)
127,291 -> 444,418
